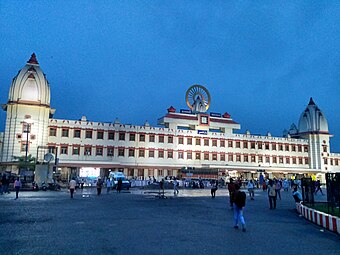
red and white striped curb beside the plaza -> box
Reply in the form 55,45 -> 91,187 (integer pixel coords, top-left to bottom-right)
296,203 -> 340,234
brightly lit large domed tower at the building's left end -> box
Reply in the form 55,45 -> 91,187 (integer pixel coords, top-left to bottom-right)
2,53 -> 54,170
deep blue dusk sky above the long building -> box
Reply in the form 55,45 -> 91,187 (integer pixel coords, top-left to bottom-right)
0,0 -> 340,152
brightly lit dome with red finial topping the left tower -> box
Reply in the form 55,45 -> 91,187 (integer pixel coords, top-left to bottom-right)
8,53 -> 50,106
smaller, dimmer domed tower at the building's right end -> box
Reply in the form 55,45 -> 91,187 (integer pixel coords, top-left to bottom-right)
298,98 -> 331,170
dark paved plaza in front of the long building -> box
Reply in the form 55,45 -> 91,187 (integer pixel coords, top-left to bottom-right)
0,186 -> 340,255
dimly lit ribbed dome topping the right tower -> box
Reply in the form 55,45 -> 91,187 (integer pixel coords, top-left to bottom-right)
299,98 -> 328,134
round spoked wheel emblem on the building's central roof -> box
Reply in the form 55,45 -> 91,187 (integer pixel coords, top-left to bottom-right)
185,84 -> 211,112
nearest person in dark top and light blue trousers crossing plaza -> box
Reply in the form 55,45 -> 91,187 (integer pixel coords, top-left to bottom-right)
233,184 -> 247,232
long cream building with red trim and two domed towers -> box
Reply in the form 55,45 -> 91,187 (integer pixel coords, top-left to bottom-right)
0,54 -> 340,182
